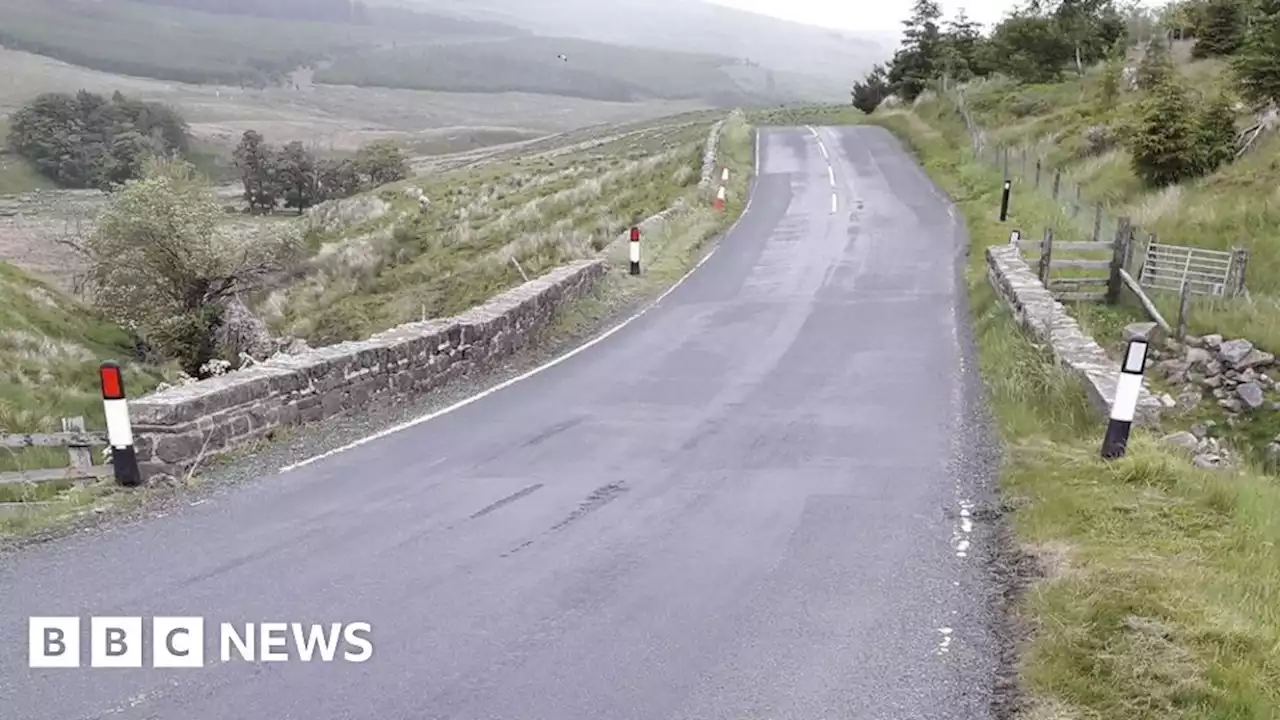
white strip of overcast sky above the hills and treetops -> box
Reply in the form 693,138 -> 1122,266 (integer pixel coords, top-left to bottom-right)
709,0 -> 1018,33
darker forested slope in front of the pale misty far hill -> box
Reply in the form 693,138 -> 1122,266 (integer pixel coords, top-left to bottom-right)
0,0 -> 788,105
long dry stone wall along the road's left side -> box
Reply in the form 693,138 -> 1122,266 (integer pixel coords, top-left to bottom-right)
129,112 -> 723,477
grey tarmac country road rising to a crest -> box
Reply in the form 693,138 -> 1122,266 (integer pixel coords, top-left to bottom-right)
0,128 -> 997,720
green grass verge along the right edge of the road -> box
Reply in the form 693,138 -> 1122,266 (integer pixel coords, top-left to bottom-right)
872,103 -> 1280,720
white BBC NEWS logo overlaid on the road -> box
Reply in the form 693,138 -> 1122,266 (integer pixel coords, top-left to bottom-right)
27,616 -> 374,667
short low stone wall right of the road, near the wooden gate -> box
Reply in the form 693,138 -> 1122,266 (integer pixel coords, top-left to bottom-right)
987,245 -> 1164,425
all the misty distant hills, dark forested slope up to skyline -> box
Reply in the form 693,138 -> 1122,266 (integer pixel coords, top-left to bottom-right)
0,0 -> 888,106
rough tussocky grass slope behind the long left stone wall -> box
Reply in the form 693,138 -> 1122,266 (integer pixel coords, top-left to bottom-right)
265,118 -> 713,343
